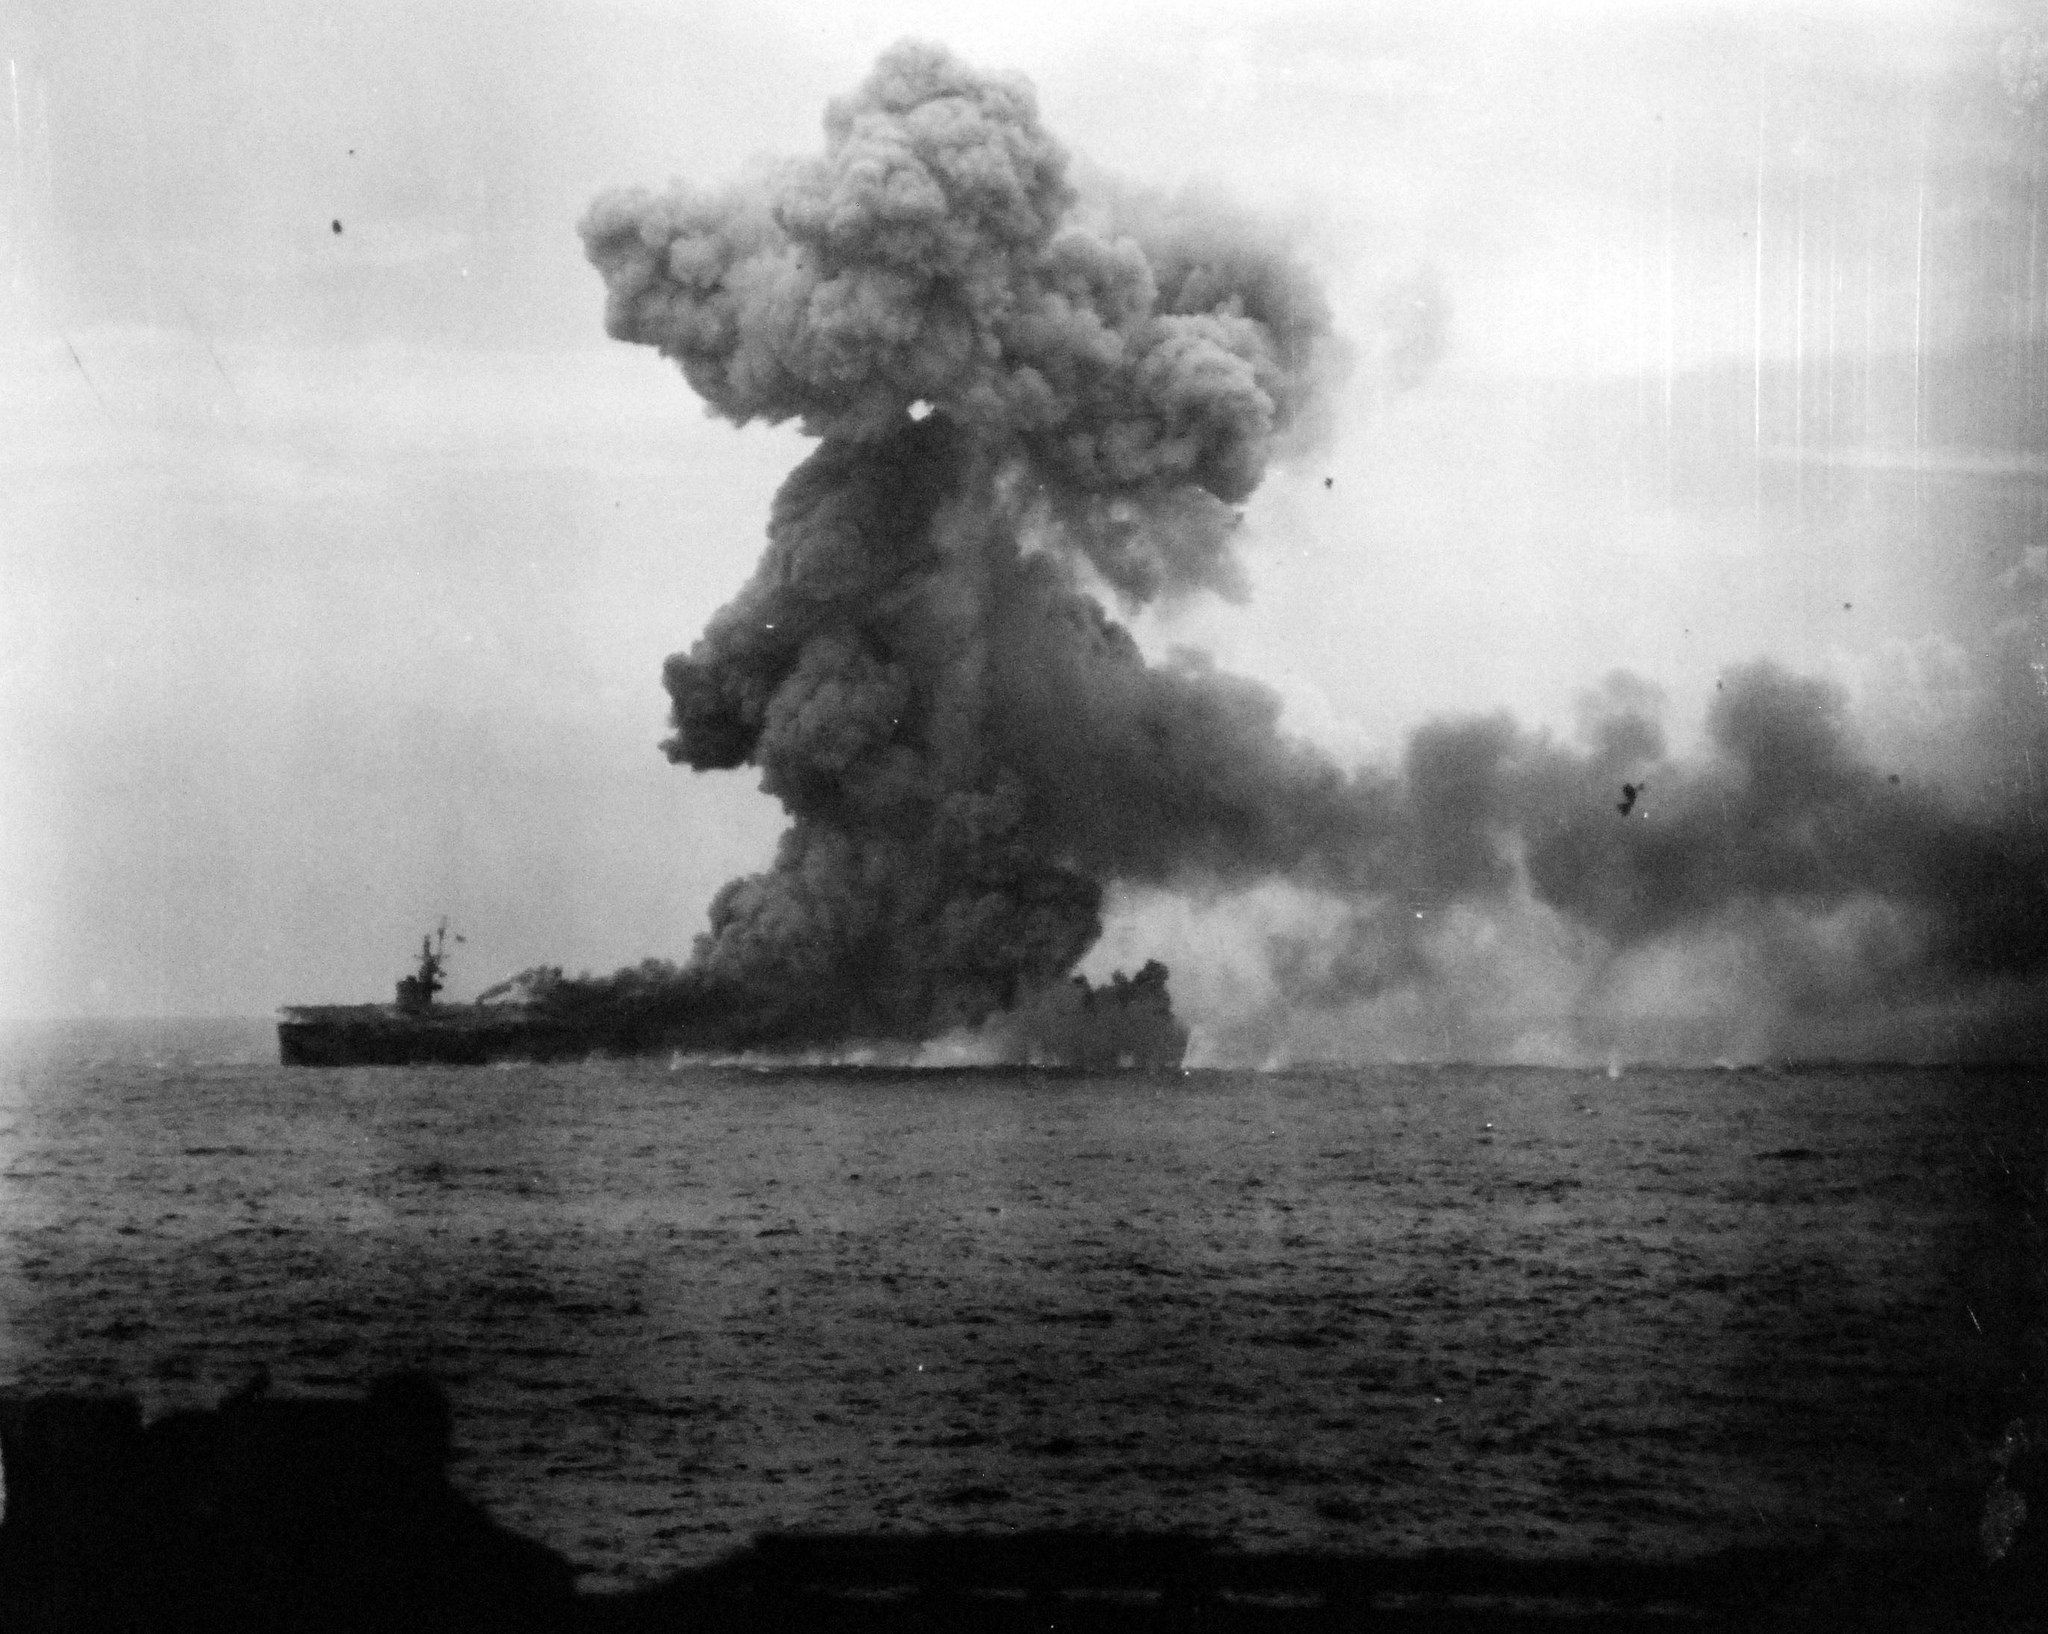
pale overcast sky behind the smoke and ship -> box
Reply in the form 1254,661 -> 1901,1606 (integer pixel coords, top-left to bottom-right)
0,0 -> 2048,1016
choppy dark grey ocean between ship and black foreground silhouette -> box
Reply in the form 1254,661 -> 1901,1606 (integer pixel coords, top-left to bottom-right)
0,1024 -> 2048,1587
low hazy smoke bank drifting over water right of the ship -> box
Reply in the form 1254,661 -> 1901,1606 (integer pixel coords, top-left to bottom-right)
1196,663 -> 2048,1059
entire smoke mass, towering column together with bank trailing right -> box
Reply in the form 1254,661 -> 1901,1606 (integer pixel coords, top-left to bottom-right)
582,45 -> 2048,1063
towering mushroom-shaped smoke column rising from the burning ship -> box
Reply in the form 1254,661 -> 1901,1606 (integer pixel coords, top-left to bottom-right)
582,45 -> 1358,1042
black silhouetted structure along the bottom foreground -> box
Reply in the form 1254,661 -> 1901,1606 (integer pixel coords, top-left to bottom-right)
0,1376 -> 2048,1634
